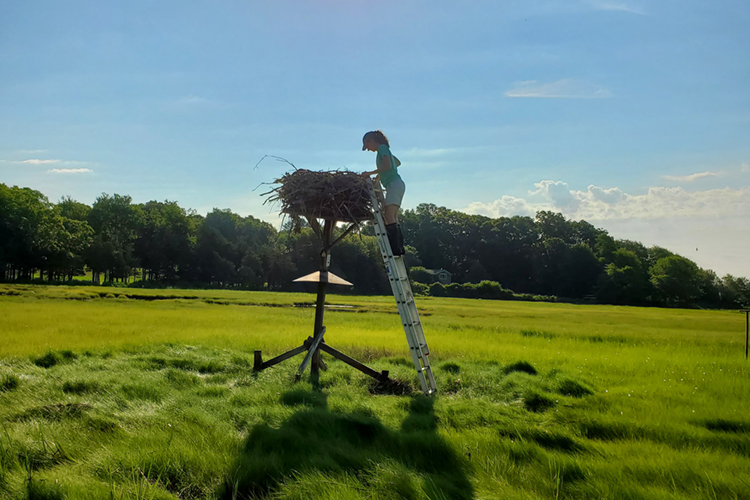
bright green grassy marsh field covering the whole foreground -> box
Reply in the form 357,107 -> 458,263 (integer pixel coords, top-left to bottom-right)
0,285 -> 750,499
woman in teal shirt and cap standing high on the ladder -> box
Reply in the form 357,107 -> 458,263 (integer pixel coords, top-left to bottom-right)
362,130 -> 406,255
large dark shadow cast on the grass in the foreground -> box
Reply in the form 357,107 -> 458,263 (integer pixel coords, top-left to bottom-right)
219,390 -> 474,500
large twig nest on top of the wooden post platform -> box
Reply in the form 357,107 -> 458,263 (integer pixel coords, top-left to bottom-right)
263,169 -> 372,223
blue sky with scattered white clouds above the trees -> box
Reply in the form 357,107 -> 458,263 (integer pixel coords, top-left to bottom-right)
0,0 -> 750,277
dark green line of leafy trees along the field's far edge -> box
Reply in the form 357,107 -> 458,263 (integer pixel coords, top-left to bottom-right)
0,184 -> 750,308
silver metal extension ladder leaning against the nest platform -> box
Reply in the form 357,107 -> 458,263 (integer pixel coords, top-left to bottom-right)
367,180 -> 437,396
